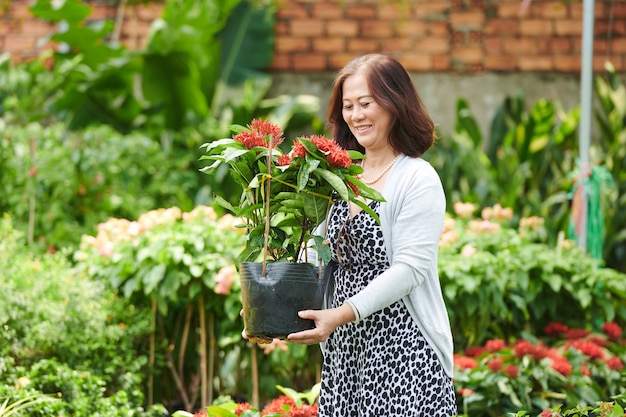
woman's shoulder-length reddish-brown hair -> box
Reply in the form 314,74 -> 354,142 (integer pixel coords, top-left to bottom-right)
328,54 -> 435,157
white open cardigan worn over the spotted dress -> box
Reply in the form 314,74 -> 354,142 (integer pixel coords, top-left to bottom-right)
347,155 -> 454,377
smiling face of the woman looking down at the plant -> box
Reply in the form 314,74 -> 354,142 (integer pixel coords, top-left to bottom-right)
342,72 -> 393,150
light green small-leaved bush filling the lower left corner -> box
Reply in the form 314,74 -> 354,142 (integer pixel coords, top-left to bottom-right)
0,216 -> 164,417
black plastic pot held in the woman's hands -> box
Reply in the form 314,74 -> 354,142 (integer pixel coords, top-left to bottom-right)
239,262 -> 324,339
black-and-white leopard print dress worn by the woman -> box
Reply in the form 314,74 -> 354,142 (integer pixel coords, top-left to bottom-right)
319,201 -> 457,417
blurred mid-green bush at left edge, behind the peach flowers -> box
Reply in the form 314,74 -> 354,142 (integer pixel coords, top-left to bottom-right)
0,123 -> 199,251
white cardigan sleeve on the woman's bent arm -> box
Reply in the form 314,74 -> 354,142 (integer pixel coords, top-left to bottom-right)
348,161 -> 445,318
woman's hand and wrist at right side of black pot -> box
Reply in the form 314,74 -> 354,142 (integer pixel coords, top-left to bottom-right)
287,304 -> 354,345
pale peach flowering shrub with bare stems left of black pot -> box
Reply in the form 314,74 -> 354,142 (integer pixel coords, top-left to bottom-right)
75,206 -> 243,408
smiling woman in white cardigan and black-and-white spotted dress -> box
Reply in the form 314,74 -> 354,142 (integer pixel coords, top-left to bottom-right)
288,54 -> 457,417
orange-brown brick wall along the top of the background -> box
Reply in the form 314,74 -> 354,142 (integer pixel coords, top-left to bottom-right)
0,0 -> 626,73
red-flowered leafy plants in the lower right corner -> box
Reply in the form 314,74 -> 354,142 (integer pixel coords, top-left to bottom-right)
454,322 -> 626,417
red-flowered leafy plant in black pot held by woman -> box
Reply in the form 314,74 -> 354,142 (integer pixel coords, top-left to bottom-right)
202,119 -> 383,339
